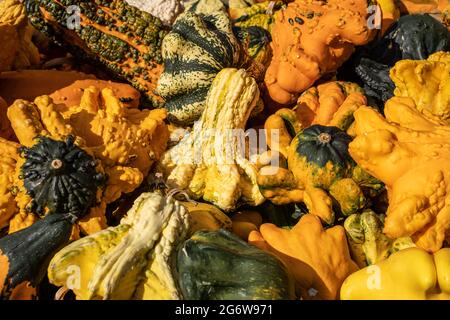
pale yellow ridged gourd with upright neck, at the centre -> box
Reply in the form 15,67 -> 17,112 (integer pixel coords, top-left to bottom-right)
157,68 -> 264,211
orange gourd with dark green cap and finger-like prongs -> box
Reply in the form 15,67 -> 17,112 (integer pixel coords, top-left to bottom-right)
258,125 -> 382,224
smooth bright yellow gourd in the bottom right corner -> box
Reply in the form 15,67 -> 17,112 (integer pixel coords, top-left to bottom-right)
341,248 -> 450,300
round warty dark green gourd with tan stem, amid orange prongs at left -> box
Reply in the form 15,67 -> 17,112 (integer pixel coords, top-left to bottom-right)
20,136 -> 106,217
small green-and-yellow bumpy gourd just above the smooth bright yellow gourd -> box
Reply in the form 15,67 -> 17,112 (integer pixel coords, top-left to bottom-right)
344,210 -> 414,268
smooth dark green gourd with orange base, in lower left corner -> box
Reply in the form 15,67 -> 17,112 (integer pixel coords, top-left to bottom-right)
0,214 -> 73,300
